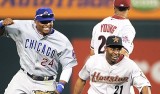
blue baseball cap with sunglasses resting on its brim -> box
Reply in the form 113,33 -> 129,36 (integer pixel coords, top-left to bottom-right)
35,7 -> 55,21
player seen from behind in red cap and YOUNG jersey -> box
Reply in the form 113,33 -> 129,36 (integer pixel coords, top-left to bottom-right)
90,0 -> 136,94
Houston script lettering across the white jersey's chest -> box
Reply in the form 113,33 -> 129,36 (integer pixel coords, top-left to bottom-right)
91,72 -> 128,84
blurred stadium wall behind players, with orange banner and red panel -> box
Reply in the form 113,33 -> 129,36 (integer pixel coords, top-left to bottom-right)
0,0 -> 160,94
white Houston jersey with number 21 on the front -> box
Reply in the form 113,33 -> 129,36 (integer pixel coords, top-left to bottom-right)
79,54 -> 151,94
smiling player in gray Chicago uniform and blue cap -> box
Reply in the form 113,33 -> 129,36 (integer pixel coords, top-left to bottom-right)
0,7 -> 77,94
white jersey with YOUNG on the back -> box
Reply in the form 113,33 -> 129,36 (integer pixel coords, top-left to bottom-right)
91,16 -> 136,54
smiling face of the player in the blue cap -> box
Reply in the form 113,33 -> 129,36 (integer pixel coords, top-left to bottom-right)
35,20 -> 53,35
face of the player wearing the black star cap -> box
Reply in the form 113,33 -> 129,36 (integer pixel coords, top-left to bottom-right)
106,46 -> 122,65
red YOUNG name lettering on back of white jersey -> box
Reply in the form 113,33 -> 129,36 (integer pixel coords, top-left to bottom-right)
101,24 -> 117,34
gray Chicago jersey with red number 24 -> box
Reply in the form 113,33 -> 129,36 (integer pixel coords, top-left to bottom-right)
4,20 -> 77,77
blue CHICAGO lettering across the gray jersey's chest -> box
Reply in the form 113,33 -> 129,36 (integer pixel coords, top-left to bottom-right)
25,39 -> 55,58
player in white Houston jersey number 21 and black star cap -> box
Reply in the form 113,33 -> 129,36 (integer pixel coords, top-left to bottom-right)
74,36 -> 151,94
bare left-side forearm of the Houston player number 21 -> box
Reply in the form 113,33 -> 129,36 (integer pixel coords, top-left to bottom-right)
73,77 -> 86,94
